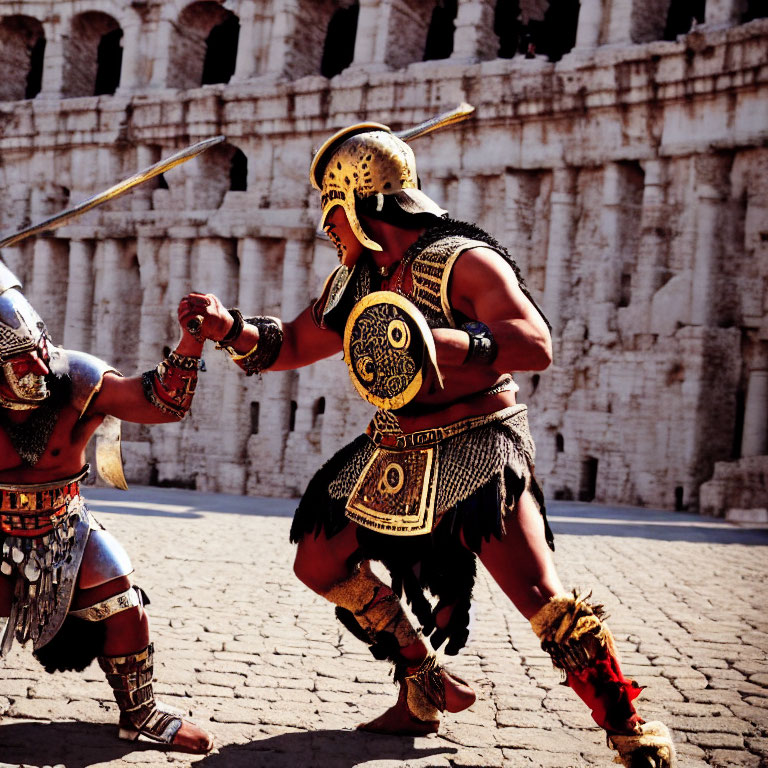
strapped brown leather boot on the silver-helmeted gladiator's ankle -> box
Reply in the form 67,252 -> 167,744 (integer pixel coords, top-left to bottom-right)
99,643 -> 181,744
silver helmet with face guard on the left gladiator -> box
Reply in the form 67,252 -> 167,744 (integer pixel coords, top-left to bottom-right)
0,262 -> 50,410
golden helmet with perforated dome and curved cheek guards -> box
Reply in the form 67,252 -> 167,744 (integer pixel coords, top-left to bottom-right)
309,123 -> 447,251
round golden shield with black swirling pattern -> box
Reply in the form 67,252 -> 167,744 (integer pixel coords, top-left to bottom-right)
344,291 -> 442,410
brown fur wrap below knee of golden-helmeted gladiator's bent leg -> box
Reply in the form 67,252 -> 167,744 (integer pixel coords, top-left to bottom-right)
323,562 -> 418,661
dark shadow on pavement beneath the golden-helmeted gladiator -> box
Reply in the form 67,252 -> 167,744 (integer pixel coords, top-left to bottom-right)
196,730 -> 457,768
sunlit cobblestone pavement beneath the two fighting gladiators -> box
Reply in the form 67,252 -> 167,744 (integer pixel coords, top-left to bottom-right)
0,488 -> 768,768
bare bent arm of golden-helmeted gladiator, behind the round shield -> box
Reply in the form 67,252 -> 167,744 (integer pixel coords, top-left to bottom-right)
434,248 -> 552,373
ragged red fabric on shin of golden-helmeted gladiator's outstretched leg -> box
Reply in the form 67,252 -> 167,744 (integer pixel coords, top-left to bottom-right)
566,648 -> 644,732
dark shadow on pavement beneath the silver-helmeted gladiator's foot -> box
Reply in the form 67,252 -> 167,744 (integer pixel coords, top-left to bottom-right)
0,721 -> 166,768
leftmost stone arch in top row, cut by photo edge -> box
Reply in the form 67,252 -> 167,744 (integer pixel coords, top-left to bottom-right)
0,16 -> 45,101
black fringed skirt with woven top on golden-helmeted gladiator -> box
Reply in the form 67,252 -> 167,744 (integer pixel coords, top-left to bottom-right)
290,411 -> 555,655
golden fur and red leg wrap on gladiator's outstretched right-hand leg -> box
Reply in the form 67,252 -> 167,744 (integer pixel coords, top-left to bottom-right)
531,590 -> 643,733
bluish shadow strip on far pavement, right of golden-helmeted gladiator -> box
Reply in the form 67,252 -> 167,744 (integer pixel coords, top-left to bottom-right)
547,501 -> 768,546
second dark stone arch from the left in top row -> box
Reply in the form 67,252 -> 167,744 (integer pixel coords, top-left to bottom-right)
62,11 -> 123,98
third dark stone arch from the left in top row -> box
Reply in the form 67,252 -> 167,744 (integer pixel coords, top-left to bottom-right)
168,0 -> 240,89
